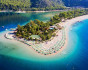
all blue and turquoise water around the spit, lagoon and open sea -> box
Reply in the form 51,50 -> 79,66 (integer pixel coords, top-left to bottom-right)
0,12 -> 88,70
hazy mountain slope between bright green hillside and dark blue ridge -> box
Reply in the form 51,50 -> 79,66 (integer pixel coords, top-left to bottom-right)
31,0 -> 63,8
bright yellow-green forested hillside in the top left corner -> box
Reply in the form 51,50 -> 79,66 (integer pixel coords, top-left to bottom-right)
0,0 -> 31,11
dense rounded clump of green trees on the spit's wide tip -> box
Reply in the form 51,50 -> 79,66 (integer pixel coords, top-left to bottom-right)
16,19 -> 55,41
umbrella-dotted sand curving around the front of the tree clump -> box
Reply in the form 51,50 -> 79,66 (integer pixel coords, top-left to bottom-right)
4,29 -> 65,55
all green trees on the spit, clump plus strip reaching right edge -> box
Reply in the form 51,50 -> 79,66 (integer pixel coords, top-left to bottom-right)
16,9 -> 88,41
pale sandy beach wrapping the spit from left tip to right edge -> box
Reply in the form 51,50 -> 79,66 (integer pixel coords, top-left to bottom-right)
1,15 -> 88,56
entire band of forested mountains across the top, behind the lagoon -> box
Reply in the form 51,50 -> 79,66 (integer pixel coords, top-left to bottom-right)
0,0 -> 88,10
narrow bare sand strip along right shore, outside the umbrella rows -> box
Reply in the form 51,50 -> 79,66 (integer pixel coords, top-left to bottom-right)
58,15 -> 88,52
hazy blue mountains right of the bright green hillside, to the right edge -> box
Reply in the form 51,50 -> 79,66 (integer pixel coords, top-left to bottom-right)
30,0 -> 88,7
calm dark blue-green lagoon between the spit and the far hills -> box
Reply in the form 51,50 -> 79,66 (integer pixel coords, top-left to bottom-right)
0,12 -> 59,32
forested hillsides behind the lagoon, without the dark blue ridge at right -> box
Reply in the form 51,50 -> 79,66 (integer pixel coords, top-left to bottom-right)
0,0 -> 66,11
